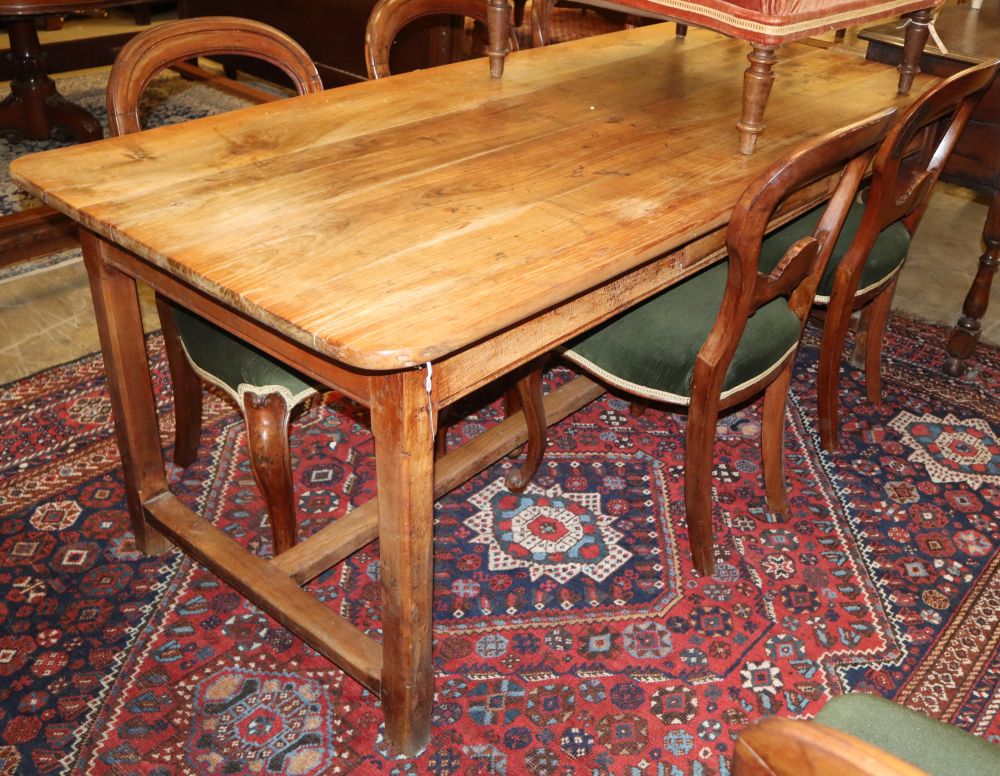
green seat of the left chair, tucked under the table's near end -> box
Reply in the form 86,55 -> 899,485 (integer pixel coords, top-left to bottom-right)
174,306 -> 316,407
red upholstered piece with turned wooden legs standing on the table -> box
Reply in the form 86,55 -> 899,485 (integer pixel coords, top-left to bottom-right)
524,0 -> 944,154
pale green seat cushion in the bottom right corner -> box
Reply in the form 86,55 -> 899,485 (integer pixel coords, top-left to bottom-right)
816,693 -> 1000,776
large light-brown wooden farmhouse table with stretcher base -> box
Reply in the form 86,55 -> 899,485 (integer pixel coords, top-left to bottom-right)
11,25 -> 936,755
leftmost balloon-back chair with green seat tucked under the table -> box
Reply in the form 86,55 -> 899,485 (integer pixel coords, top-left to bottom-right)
107,16 -> 323,554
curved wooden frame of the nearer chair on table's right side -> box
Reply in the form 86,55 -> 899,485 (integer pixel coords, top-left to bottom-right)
566,109 -> 895,575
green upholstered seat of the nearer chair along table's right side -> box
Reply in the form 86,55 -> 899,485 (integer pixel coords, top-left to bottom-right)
564,263 -> 801,404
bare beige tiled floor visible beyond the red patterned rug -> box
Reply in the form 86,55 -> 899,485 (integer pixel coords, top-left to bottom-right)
0,6 -> 1000,384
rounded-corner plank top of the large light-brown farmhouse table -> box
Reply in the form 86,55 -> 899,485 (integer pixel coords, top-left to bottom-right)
11,25 -> 933,370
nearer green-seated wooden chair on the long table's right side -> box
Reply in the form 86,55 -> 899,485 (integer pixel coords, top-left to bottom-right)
536,109 -> 894,574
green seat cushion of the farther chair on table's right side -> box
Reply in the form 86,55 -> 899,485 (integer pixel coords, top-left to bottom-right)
760,202 -> 910,300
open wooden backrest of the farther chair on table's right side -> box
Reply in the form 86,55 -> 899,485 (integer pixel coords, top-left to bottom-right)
845,61 -> 1000,247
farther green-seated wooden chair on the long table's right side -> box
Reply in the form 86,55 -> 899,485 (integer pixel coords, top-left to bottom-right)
762,62 -> 998,450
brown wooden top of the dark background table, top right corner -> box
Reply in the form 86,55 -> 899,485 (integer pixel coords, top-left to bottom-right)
858,0 -> 1000,64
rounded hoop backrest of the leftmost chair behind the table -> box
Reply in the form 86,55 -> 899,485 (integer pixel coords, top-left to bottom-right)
107,16 -> 323,136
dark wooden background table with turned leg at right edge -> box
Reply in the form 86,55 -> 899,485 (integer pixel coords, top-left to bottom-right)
858,0 -> 1000,376
